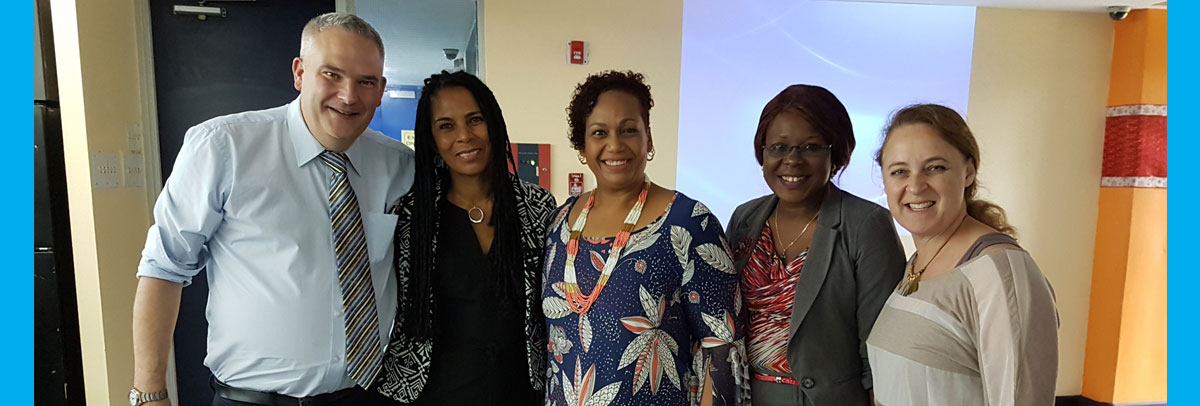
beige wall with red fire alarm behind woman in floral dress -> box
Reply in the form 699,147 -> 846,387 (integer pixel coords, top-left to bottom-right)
480,0 -> 683,202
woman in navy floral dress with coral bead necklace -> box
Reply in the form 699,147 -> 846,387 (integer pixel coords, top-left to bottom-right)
542,72 -> 749,406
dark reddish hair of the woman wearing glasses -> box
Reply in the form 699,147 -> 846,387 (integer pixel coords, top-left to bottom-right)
754,84 -> 854,175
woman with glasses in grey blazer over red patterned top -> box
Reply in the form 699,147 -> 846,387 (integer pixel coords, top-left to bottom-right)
727,85 -> 905,406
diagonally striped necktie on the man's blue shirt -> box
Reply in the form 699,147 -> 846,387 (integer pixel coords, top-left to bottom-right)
320,150 -> 383,388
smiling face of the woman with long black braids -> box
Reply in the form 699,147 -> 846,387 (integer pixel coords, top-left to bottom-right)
430,86 -> 492,177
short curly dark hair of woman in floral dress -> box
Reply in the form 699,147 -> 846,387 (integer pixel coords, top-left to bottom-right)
566,71 -> 654,151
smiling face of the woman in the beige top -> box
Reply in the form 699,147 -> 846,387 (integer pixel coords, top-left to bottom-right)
880,123 -> 976,238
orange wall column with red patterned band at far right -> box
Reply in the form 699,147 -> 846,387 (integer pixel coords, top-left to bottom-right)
1082,10 -> 1166,404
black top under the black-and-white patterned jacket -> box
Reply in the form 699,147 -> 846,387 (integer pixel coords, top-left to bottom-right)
416,201 -> 542,405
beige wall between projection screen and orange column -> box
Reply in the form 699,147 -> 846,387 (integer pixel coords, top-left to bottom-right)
967,8 -> 1112,395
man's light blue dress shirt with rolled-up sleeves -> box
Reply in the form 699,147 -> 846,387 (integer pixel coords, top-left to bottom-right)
138,98 -> 413,396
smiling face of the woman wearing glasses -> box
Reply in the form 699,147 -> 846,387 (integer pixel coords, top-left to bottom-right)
762,109 -> 832,204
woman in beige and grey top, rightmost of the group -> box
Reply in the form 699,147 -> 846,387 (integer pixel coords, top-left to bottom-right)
866,105 -> 1058,406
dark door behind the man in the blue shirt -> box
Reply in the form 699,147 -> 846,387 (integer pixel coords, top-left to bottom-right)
150,0 -> 335,405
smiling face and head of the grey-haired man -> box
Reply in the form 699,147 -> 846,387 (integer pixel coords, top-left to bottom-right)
292,28 -> 386,151
